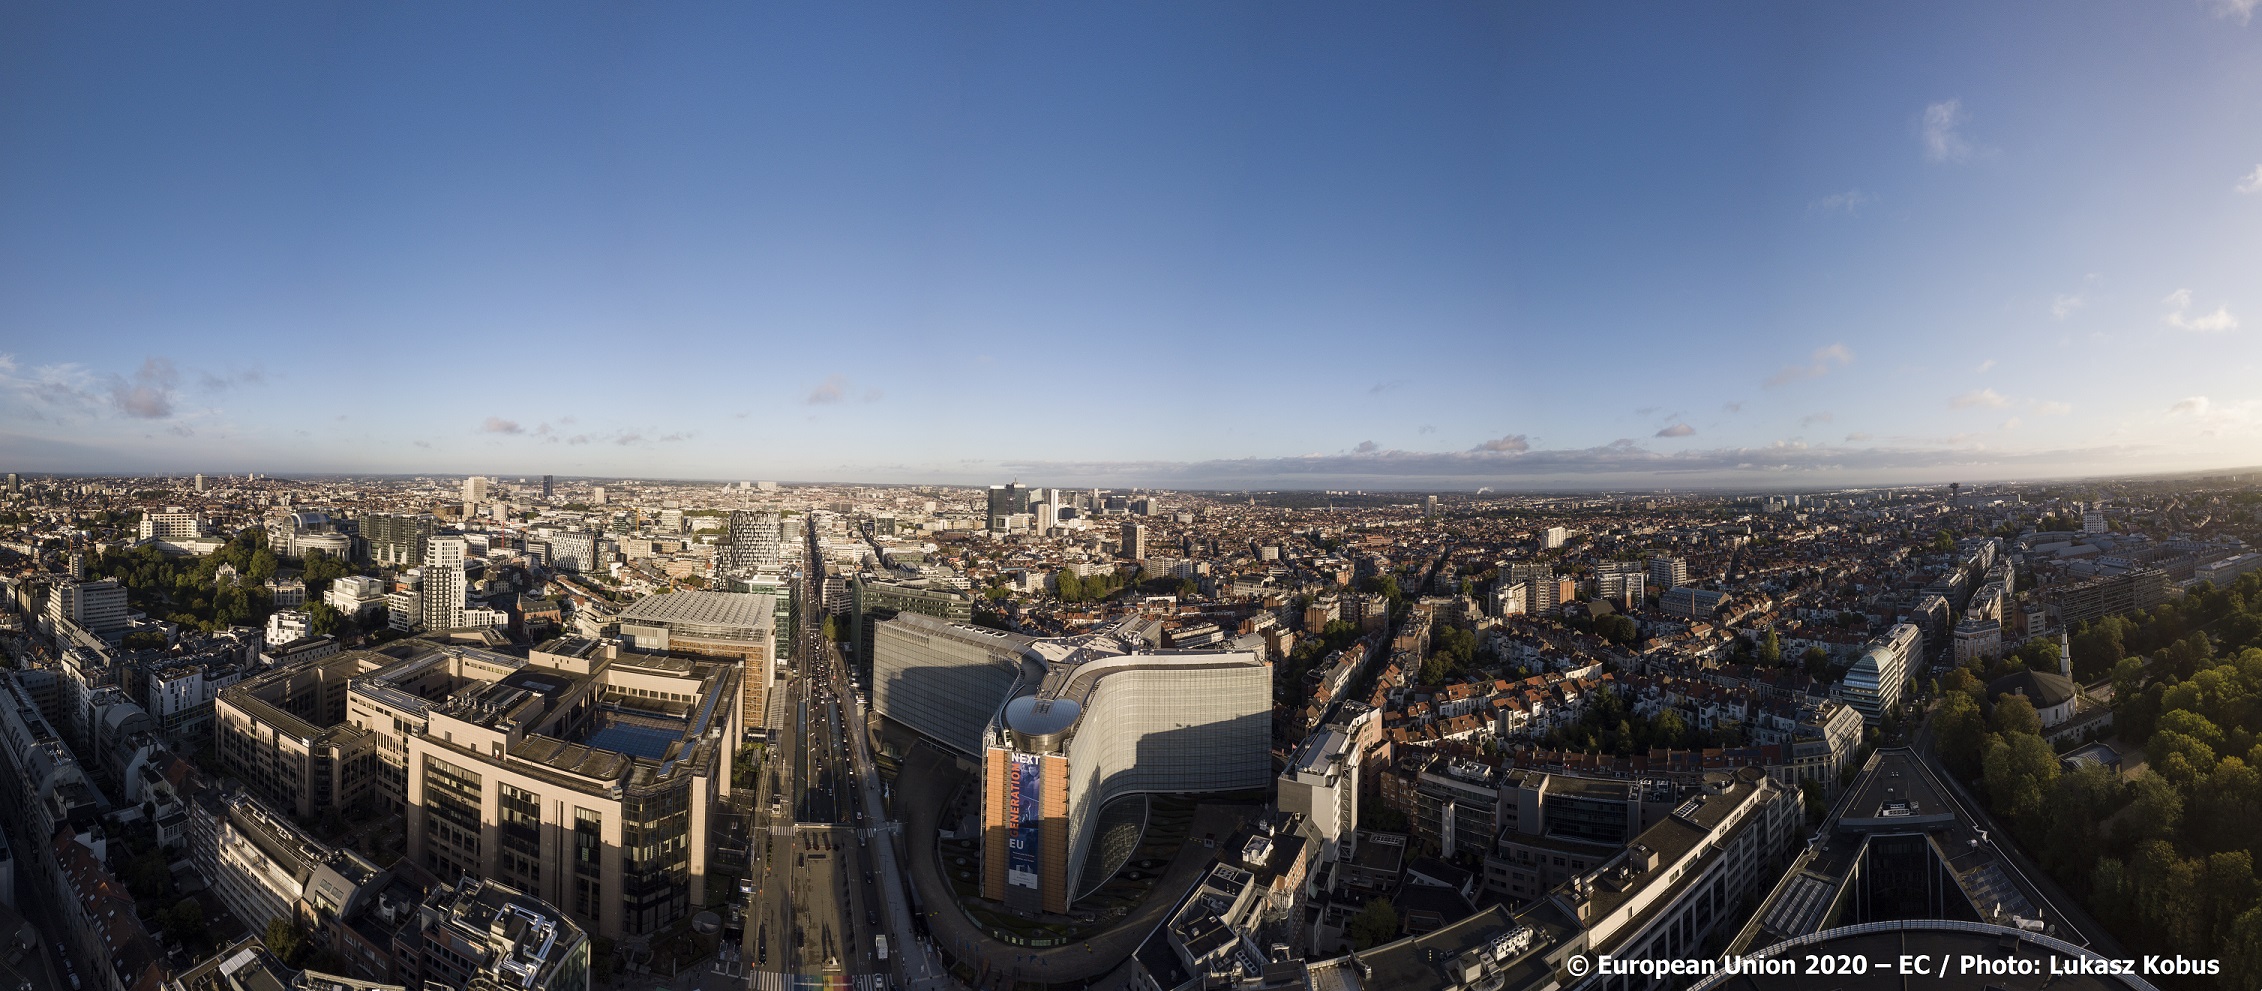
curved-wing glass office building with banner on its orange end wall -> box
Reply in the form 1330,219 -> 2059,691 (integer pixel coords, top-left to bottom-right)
873,613 -> 1271,912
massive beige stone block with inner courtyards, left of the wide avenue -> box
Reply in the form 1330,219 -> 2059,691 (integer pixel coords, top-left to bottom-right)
217,640 -> 744,939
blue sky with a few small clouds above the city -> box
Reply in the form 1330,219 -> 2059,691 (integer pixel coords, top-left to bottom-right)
0,0 -> 2262,489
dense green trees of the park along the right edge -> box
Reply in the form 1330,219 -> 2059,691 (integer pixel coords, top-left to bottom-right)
1934,572 -> 2262,989
